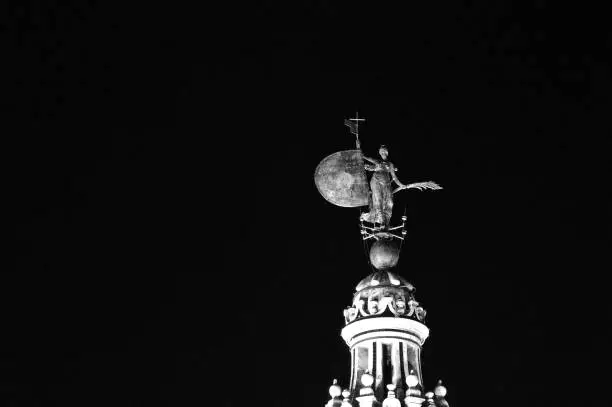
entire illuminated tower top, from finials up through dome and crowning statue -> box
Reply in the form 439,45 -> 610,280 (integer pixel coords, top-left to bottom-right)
314,118 -> 448,407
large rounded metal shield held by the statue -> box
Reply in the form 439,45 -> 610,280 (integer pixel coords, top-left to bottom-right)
314,150 -> 370,208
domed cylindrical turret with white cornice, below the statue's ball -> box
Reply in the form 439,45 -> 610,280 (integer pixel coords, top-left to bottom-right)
341,271 -> 429,401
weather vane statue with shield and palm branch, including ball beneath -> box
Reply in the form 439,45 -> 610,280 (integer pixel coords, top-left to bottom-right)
314,114 -> 442,270
